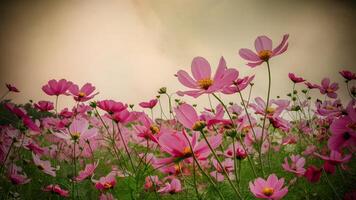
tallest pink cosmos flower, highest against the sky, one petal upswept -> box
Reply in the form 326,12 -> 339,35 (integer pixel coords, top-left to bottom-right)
239,34 -> 289,67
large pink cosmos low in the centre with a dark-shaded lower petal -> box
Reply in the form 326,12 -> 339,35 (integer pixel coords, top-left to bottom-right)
158,129 -> 222,164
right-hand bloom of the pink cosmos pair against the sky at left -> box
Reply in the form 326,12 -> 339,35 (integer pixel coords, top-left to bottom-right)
69,83 -> 99,102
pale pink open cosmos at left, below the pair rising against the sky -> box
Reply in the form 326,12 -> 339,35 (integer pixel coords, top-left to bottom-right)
53,118 -> 98,142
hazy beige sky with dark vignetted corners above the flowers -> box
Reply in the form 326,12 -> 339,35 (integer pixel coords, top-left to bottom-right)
0,0 -> 356,111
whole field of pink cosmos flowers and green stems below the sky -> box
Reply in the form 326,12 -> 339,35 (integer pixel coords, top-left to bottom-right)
0,34 -> 356,200
